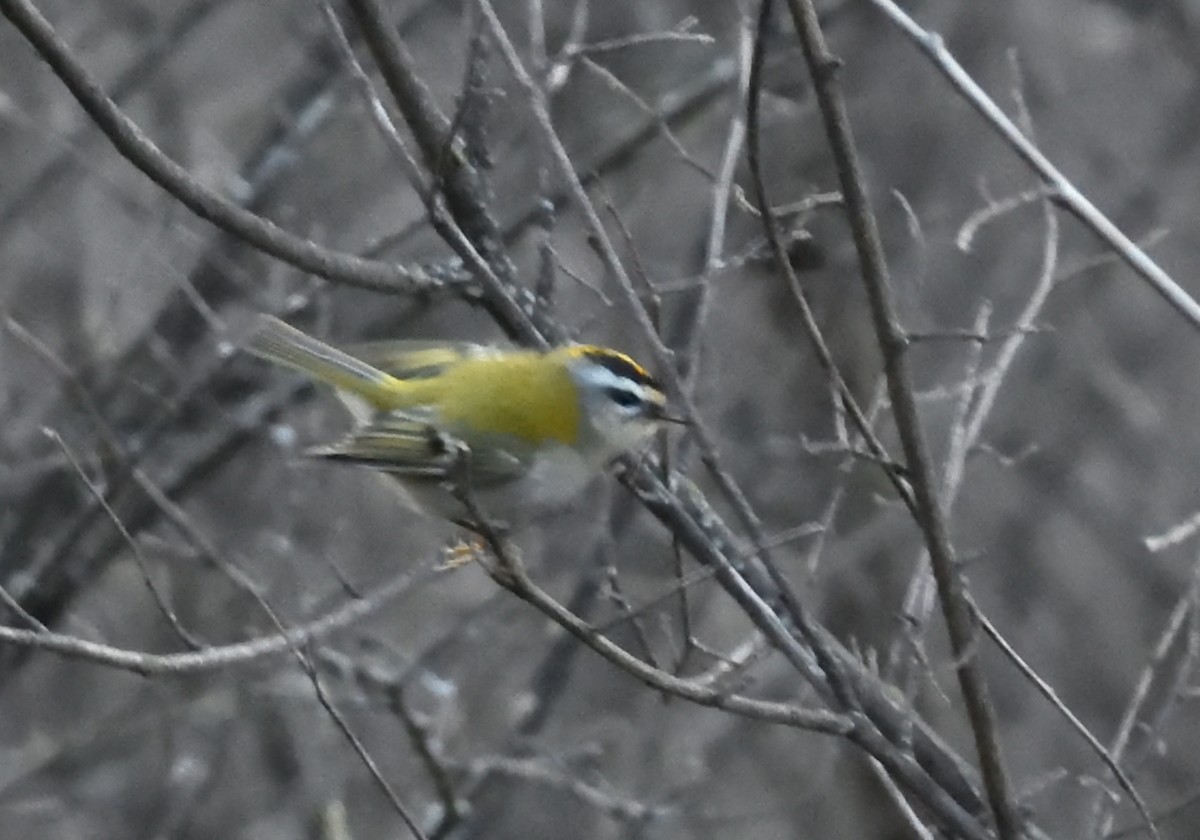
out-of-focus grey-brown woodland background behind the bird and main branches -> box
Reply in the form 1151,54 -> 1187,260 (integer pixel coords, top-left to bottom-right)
0,0 -> 1200,840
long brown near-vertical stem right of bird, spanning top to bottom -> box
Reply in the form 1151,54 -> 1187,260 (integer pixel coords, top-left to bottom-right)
787,0 -> 1021,840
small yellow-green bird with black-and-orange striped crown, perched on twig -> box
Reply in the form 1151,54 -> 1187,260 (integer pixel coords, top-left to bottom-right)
247,316 -> 678,524
